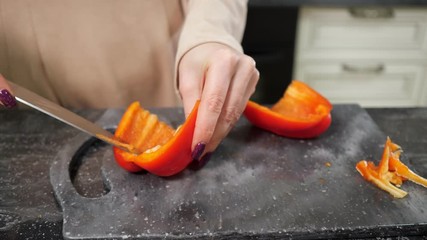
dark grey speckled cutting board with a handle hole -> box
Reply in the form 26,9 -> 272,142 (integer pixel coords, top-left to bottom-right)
50,105 -> 427,239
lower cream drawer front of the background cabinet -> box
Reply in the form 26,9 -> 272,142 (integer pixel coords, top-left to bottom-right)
295,61 -> 425,107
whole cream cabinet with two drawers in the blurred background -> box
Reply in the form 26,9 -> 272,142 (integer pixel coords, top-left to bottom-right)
294,7 -> 427,107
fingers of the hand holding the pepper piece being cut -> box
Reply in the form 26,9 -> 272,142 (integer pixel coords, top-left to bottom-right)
193,50 -> 259,157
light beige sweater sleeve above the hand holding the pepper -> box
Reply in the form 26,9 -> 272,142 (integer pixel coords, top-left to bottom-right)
175,0 -> 247,90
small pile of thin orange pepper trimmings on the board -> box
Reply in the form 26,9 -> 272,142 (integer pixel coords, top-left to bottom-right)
356,137 -> 427,198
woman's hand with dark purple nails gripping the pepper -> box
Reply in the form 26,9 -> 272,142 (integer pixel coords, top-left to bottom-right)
178,43 -> 259,164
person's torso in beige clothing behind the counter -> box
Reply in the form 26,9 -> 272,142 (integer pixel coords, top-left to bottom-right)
0,0 -> 183,108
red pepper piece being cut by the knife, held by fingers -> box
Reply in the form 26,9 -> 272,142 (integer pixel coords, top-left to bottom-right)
113,101 -> 199,176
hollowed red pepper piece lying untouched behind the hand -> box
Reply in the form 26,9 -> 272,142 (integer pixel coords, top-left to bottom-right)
244,80 -> 332,138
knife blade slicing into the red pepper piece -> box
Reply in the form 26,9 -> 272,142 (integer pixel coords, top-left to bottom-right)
7,81 -> 138,154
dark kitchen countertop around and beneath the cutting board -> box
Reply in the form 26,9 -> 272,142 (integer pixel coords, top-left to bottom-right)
0,108 -> 427,239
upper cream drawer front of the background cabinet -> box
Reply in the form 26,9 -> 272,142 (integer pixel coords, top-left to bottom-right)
297,7 -> 427,60
